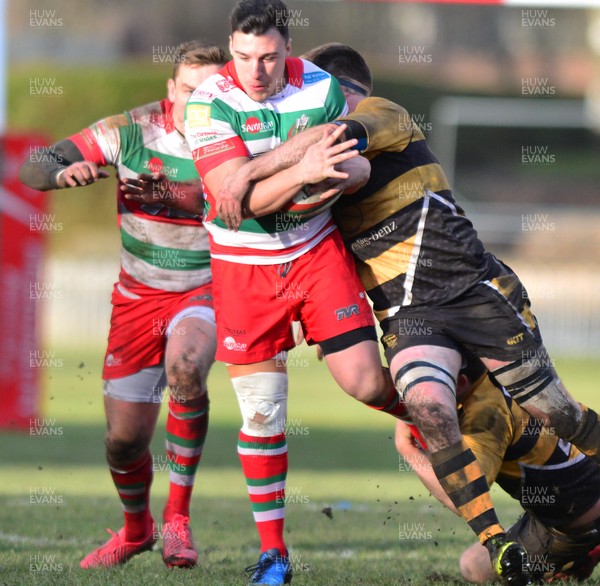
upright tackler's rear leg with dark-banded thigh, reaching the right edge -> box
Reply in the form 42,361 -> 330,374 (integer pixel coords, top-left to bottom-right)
482,346 -> 600,462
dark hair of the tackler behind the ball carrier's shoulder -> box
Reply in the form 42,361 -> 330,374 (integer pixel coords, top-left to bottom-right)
302,43 -> 373,94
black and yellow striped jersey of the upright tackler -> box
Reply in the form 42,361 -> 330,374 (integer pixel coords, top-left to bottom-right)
334,98 -> 499,320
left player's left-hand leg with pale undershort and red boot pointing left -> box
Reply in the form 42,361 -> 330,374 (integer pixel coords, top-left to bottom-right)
80,367 -> 164,568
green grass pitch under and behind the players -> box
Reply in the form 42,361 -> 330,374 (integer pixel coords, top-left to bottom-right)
0,350 -> 599,586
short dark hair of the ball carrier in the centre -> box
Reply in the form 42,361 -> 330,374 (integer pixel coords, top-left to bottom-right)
229,0 -> 290,41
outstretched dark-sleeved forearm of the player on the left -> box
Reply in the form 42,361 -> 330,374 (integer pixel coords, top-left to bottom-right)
19,140 -> 84,191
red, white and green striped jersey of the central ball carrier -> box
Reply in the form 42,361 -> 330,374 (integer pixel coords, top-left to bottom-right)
185,58 -> 347,264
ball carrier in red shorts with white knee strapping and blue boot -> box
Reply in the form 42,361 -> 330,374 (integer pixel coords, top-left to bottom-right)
185,0 -> 408,584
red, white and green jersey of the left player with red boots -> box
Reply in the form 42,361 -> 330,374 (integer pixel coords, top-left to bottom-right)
69,100 -> 211,292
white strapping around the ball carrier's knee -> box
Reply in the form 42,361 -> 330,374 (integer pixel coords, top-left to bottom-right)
231,372 -> 288,437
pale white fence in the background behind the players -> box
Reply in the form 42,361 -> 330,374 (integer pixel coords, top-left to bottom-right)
40,259 -> 600,358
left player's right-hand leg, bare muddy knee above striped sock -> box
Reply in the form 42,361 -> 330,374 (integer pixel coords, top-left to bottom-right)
162,314 -> 216,568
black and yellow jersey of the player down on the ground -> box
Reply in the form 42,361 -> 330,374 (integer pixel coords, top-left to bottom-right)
459,376 -> 600,527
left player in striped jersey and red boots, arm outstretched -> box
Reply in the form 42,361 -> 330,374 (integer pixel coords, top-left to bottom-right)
20,41 -> 226,568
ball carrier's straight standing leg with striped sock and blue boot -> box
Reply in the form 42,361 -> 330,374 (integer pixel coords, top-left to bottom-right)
229,360 -> 292,584
